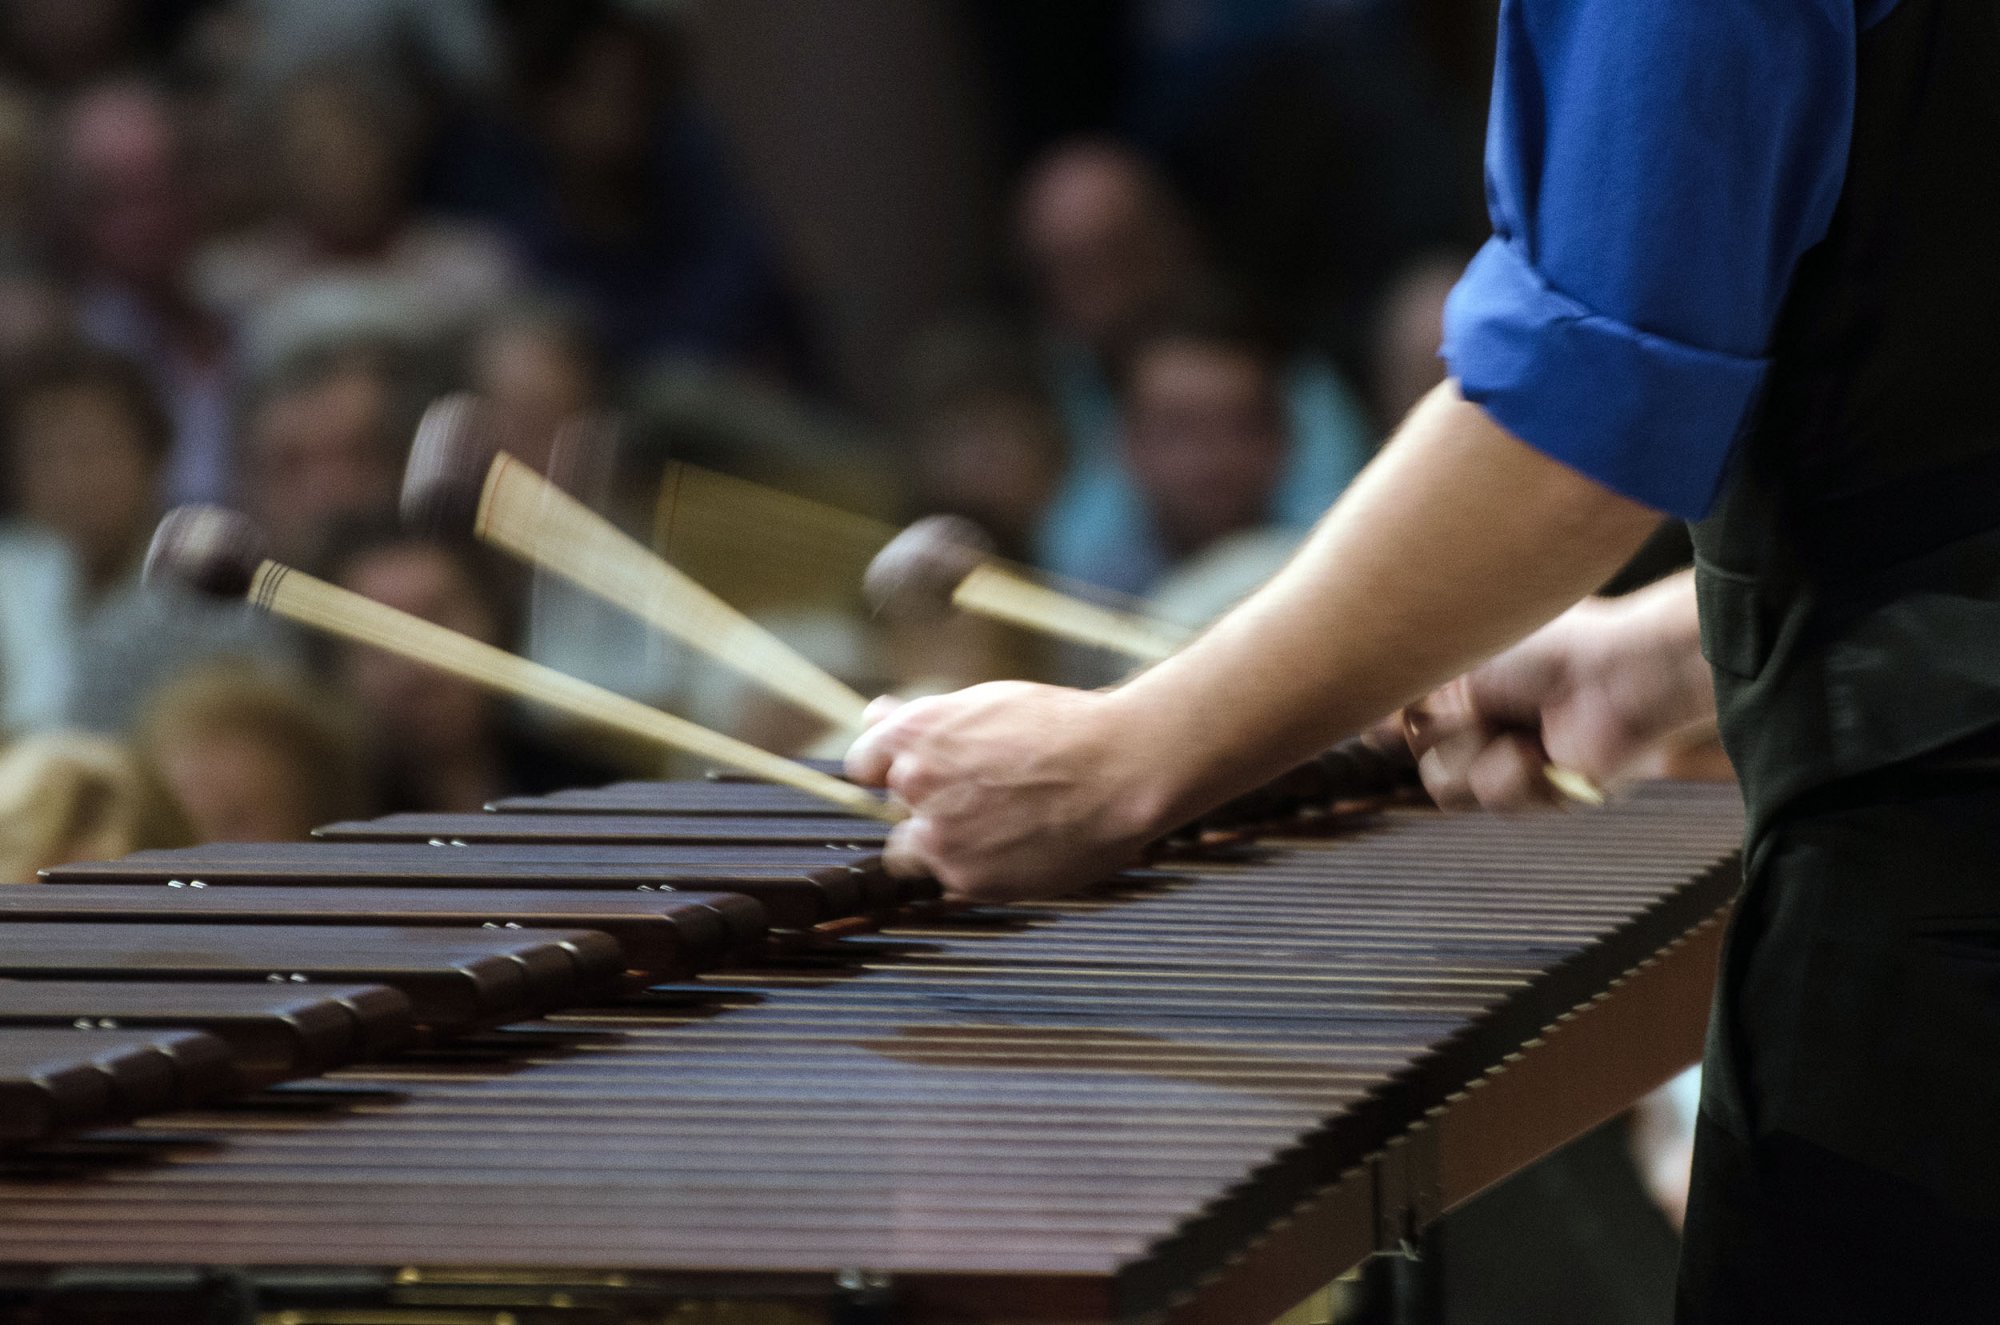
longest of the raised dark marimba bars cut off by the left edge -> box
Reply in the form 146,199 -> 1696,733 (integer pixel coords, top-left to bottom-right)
0,881 -> 764,977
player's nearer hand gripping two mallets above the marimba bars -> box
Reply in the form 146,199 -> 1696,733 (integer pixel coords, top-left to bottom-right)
848,681 -> 1166,901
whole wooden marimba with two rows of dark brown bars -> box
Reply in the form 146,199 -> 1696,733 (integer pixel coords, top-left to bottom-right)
0,783 -> 1742,1325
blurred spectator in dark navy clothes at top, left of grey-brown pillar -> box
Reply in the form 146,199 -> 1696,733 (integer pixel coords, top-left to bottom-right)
436,0 -> 790,374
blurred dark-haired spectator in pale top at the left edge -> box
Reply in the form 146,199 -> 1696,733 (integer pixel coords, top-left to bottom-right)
0,346 -> 278,731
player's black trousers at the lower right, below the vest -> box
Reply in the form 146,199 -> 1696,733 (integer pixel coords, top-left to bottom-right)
1676,761 -> 2000,1325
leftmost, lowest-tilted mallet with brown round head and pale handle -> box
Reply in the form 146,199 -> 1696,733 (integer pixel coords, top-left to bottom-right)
146,506 -> 902,823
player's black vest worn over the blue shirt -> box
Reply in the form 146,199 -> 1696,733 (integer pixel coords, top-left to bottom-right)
1694,0 -> 2000,841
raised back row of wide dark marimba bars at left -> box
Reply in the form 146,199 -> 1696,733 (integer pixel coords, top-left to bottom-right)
0,783 -> 920,1145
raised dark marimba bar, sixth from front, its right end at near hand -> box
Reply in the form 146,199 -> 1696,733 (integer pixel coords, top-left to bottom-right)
314,815 -> 888,847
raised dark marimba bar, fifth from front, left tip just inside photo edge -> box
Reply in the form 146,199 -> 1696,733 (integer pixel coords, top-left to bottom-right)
44,843 -> 868,932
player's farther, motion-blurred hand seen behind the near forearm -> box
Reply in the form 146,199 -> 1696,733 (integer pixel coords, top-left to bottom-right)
1406,584 -> 1714,809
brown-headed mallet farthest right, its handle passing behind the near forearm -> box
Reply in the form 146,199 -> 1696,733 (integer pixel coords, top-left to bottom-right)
862,514 -> 1186,663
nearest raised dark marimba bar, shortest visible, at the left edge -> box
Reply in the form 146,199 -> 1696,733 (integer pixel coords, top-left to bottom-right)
0,1027 -> 240,1143
